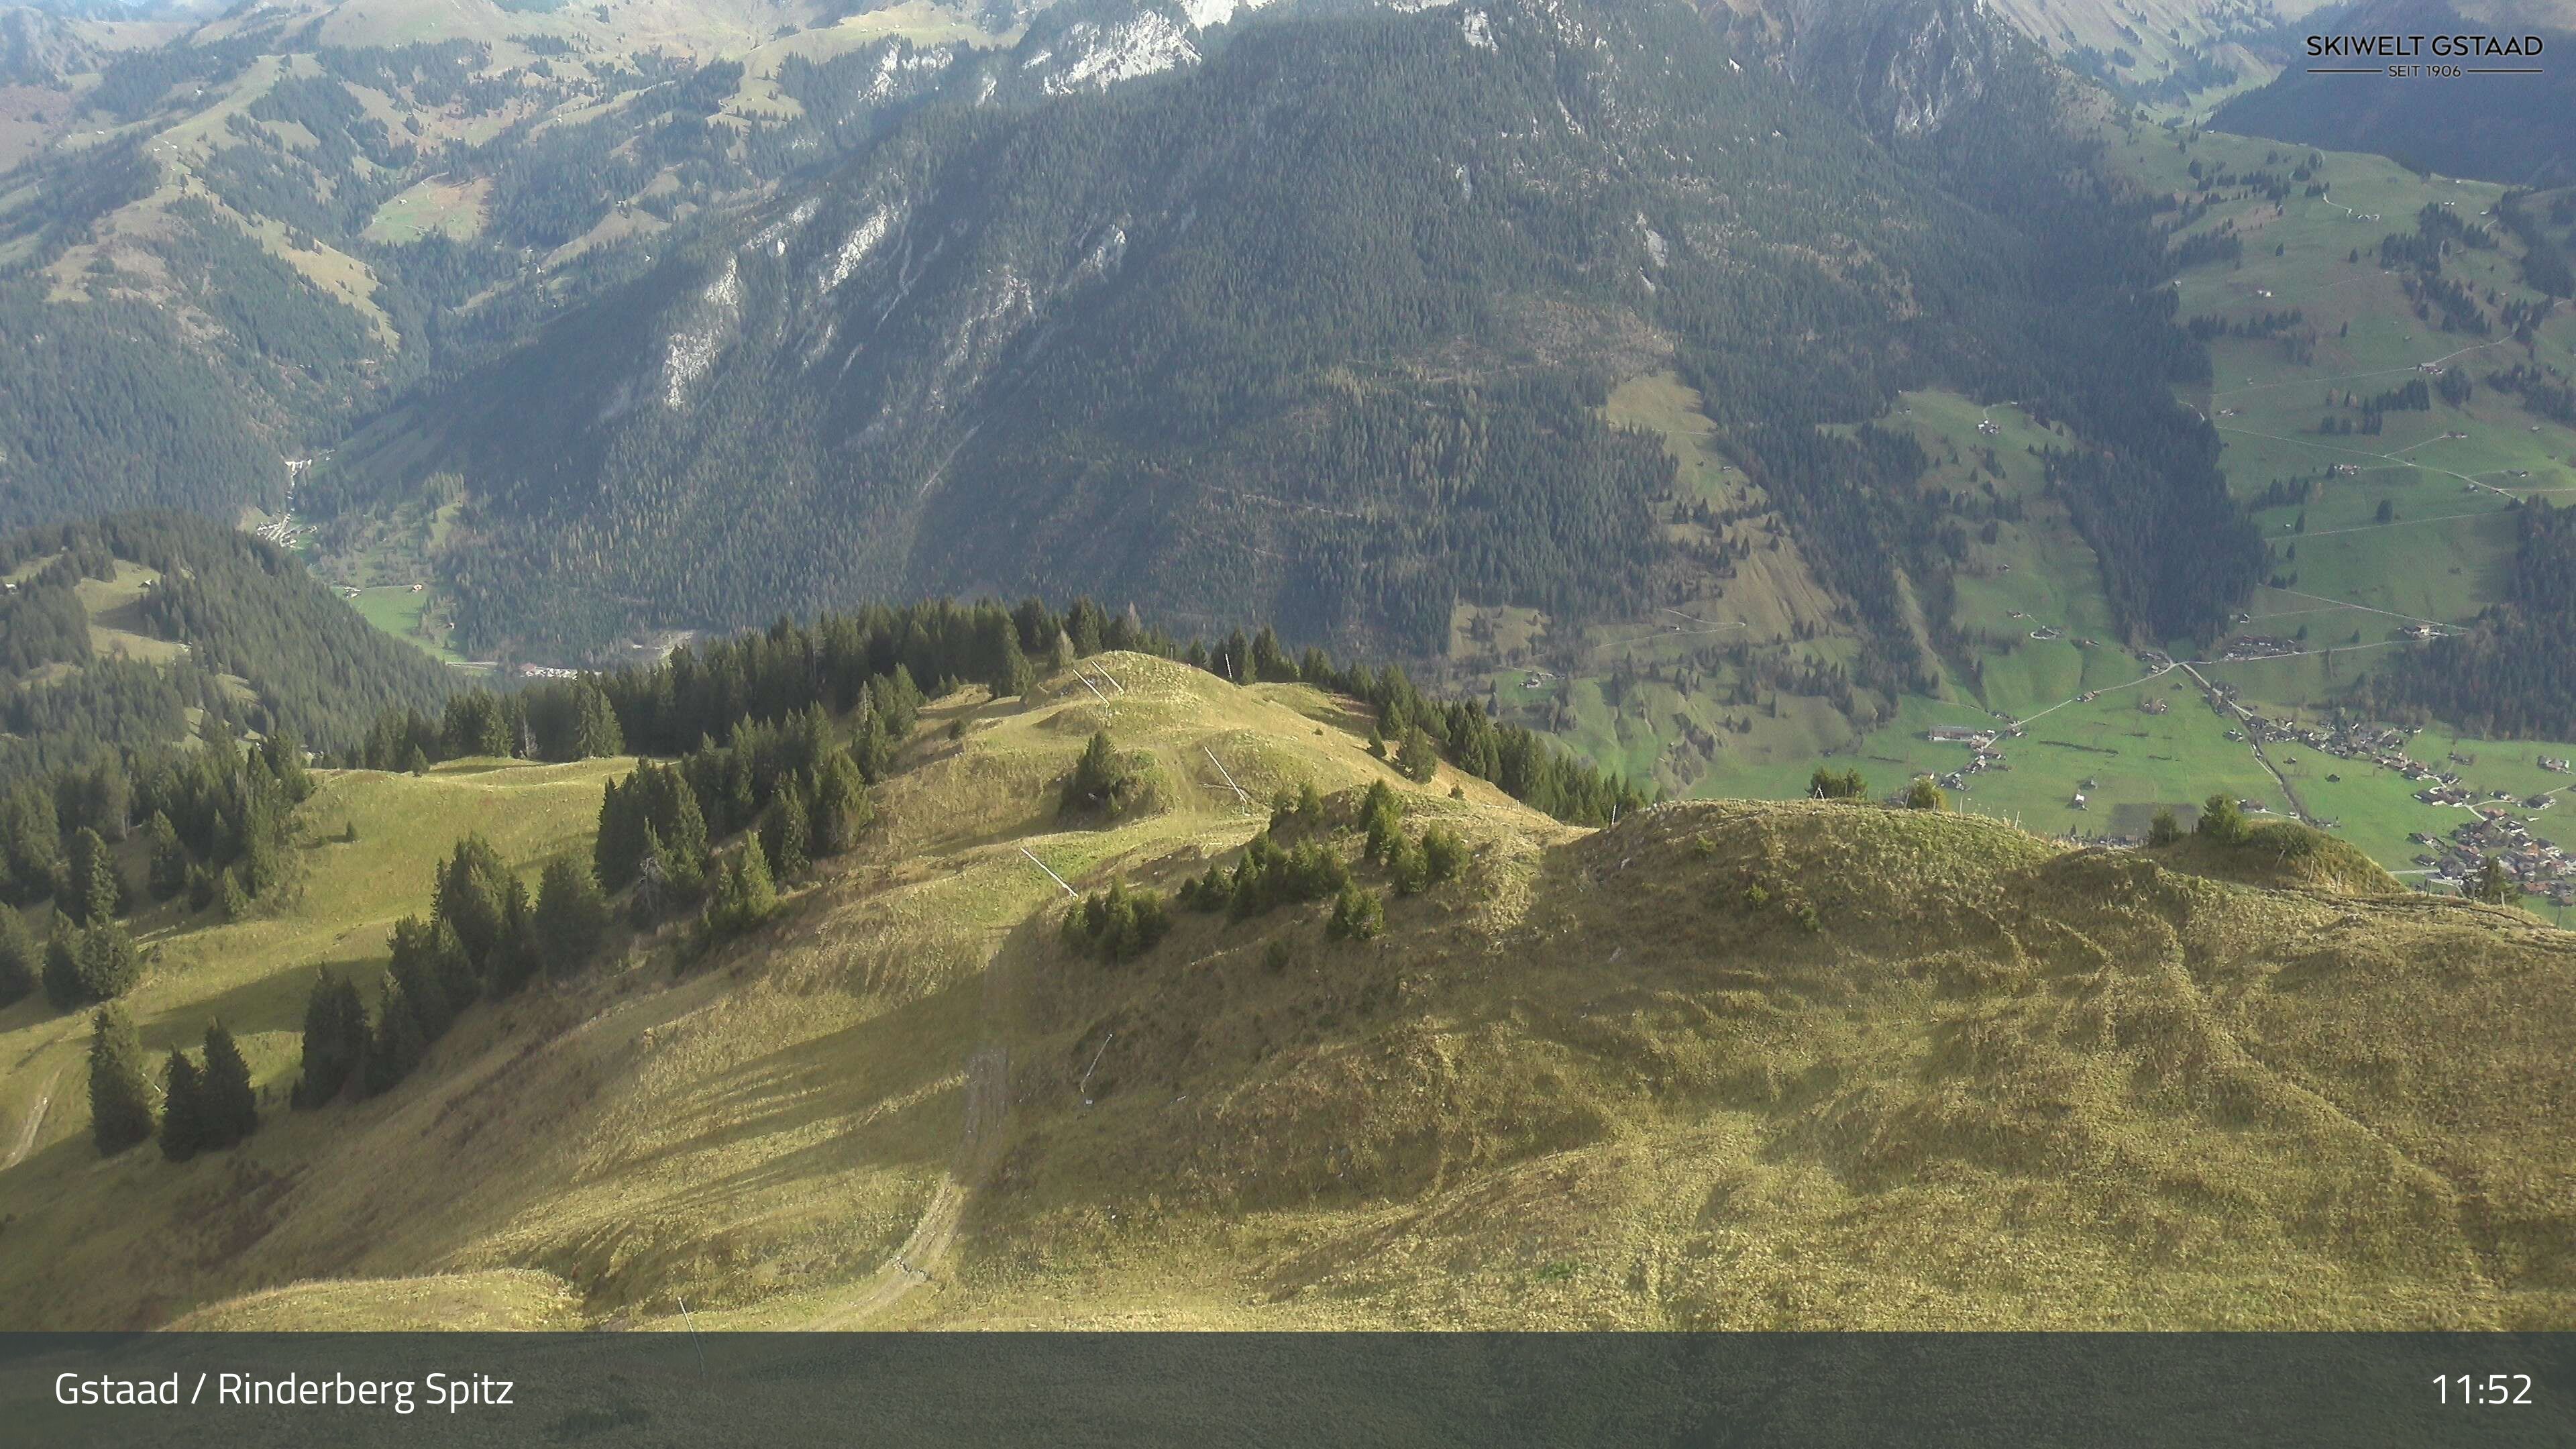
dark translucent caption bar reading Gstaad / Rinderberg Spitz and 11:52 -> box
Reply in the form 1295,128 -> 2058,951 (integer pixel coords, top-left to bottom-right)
0,1333 -> 2576,1449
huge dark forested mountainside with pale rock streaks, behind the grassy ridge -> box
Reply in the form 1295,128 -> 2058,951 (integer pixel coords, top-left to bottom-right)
312,5 -> 2251,684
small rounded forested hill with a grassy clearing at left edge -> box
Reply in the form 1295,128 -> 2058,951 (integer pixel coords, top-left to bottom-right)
0,513 -> 456,779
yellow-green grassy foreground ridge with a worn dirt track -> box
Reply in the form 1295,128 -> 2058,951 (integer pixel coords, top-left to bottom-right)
0,655 -> 2576,1328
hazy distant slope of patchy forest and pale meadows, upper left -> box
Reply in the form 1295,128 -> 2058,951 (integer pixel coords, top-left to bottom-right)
0,0 -> 966,529
